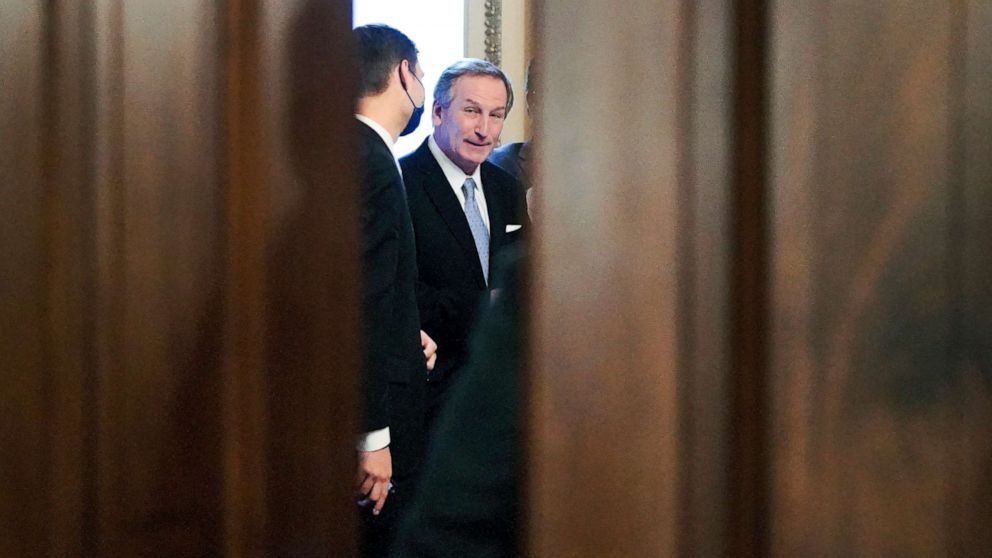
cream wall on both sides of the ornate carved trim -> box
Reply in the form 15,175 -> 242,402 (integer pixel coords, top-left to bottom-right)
465,0 -> 529,143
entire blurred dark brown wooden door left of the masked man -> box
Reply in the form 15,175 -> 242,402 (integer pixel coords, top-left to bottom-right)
0,0 -> 359,556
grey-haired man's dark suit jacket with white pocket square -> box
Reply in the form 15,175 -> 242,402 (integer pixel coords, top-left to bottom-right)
400,140 -> 527,381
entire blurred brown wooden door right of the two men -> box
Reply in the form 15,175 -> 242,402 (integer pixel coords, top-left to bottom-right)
525,0 -> 992,556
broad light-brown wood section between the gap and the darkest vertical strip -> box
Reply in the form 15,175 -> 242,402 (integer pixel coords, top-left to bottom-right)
525,0 -> 732,556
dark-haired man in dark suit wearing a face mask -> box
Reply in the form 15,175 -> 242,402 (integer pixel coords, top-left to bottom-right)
354,25 -> 437,557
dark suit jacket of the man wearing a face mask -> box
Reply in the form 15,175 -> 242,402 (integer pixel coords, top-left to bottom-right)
356,122 -> 426,482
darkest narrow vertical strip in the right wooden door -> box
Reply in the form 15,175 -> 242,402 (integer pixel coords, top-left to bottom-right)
726,0 -> 771,558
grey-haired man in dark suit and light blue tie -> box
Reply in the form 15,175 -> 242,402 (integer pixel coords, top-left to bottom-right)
400,59 -> 527,428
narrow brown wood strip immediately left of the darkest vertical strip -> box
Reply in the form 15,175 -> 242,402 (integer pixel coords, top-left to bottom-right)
676,0 -> 735,556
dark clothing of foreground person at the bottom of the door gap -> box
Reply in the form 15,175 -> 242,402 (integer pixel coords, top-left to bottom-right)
391,250 -> 527,558
